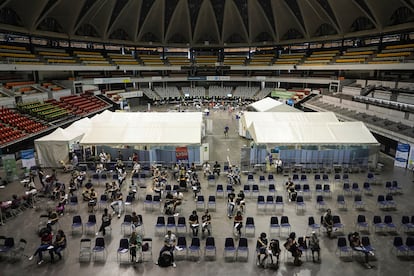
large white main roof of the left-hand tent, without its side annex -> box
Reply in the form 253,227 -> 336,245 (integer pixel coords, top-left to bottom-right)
80,111 -> 202,145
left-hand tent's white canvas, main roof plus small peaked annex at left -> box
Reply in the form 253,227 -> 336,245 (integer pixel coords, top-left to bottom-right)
35,111 -> 204,167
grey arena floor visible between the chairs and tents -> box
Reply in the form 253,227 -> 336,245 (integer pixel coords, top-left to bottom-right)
0,108 -> 414,275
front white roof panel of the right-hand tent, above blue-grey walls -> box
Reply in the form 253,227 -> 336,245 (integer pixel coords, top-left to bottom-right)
248,120 -> 378,145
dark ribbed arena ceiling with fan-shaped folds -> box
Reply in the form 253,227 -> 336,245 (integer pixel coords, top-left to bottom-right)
0,0 -> 414,47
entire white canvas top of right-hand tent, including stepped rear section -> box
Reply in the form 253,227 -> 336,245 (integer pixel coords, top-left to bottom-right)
241,112 -> 378,146
